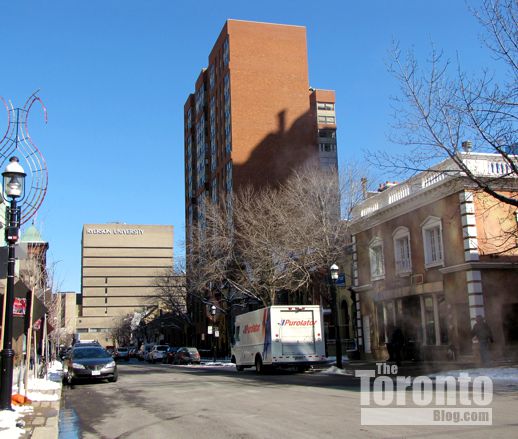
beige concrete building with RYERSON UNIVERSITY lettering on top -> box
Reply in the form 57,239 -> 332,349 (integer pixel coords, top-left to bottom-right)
76,224 -> 173,345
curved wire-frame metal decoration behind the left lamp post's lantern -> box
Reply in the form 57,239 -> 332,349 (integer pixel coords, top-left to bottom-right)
0,91 -> 48,224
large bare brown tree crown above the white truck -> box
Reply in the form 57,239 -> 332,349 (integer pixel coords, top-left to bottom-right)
188,167 -> 361,306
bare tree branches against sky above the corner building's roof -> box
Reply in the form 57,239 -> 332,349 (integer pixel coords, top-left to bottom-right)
369,0 -> 518,207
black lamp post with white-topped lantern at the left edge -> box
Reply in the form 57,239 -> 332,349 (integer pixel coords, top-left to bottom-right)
0,157 -> 27,410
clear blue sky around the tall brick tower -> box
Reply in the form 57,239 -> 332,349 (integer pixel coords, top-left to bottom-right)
0,0 -> 491,291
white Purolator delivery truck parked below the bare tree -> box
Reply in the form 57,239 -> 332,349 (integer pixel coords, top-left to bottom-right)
232,305 -> 327,373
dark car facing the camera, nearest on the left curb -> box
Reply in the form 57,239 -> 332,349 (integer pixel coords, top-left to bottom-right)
63,345 -> 118,384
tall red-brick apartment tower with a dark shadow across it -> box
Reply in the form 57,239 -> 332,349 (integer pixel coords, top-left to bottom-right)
184,20 -> 337,350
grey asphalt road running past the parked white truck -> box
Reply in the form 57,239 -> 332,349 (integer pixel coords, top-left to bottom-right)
60,360 -> 518,439
